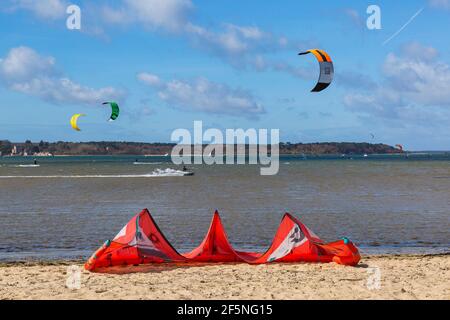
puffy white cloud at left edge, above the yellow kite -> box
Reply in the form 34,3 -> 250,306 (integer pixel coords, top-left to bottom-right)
0,47 -> 123,104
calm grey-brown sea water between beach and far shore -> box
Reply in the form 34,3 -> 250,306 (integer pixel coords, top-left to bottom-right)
0,153 -> 450,261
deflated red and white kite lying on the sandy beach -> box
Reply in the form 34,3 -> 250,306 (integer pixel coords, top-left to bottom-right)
85,209 -> 360,272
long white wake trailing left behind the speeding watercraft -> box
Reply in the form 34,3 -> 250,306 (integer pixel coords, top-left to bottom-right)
0,168 -> 193,179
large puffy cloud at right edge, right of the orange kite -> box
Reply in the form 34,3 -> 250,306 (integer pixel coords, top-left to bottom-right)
344,43 -> 450,121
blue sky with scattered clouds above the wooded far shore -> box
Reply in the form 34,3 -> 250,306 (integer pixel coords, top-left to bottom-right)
0,0 -> 450,150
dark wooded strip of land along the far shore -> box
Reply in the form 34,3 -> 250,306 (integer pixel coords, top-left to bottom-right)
0,140 -> 402,156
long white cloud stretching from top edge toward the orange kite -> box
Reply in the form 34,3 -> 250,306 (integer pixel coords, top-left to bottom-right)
100,0 -> 312,73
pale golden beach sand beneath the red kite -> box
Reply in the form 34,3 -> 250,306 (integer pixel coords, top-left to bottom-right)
0,255 -> 450,300
